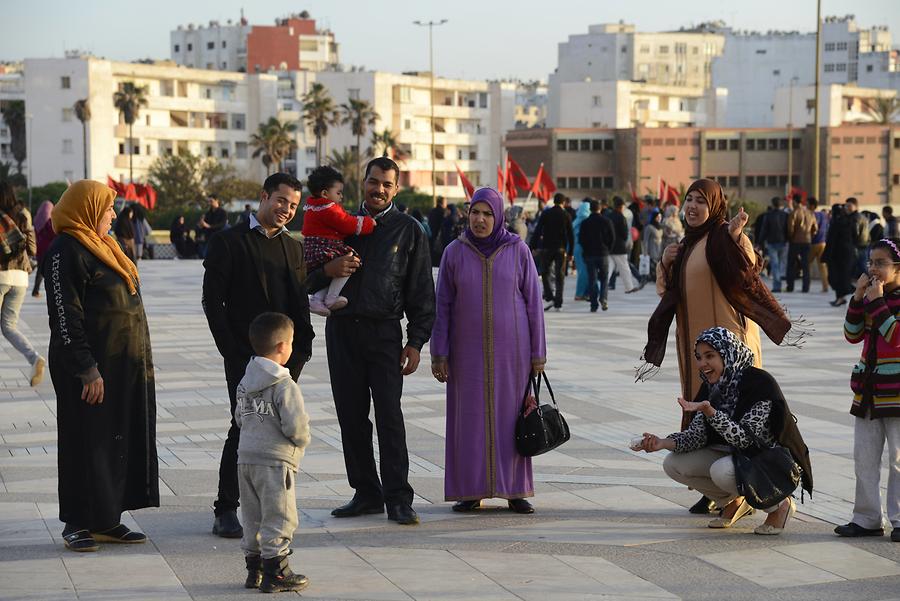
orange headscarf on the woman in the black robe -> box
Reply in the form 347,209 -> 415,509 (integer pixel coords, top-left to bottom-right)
50,179 -> 139,294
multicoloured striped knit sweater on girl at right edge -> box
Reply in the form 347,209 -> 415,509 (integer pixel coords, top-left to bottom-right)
844,288 -> 900,419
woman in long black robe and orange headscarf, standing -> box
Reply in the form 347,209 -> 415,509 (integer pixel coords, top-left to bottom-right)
44,180 -> 159,551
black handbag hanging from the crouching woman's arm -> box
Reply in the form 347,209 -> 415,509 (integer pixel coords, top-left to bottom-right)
732,428 -> 800,509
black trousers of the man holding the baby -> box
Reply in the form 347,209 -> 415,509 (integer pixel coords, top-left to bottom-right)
325,317 -> 413,505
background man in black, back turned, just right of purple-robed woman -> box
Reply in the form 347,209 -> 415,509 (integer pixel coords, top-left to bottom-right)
531,192 -> 575,311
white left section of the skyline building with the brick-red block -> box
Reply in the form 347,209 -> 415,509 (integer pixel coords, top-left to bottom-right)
169,19 -> 252,71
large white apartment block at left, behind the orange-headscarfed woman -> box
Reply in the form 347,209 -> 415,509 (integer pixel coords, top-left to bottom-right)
25,57 -> 277,185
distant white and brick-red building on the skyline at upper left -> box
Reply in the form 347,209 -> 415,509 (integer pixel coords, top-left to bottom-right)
169,13 -> 338,73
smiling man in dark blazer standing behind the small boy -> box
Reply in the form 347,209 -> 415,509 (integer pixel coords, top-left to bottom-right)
203,173 -> 315,538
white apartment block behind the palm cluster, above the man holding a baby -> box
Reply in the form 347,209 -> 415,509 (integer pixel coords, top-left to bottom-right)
279,71 -> 516,199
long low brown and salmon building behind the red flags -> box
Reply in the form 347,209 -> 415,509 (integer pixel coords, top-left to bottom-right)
506,124 -> 900,207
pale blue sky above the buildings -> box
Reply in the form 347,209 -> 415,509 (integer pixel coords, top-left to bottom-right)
0,0 -> 900,79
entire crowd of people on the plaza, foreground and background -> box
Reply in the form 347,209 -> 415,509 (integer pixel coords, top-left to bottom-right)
0,163 -> 900,592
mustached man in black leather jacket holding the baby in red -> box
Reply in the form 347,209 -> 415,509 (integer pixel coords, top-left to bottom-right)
310,157 -> 435,524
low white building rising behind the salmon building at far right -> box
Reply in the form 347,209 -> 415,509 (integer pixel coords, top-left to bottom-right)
773,84 -> 897,127
